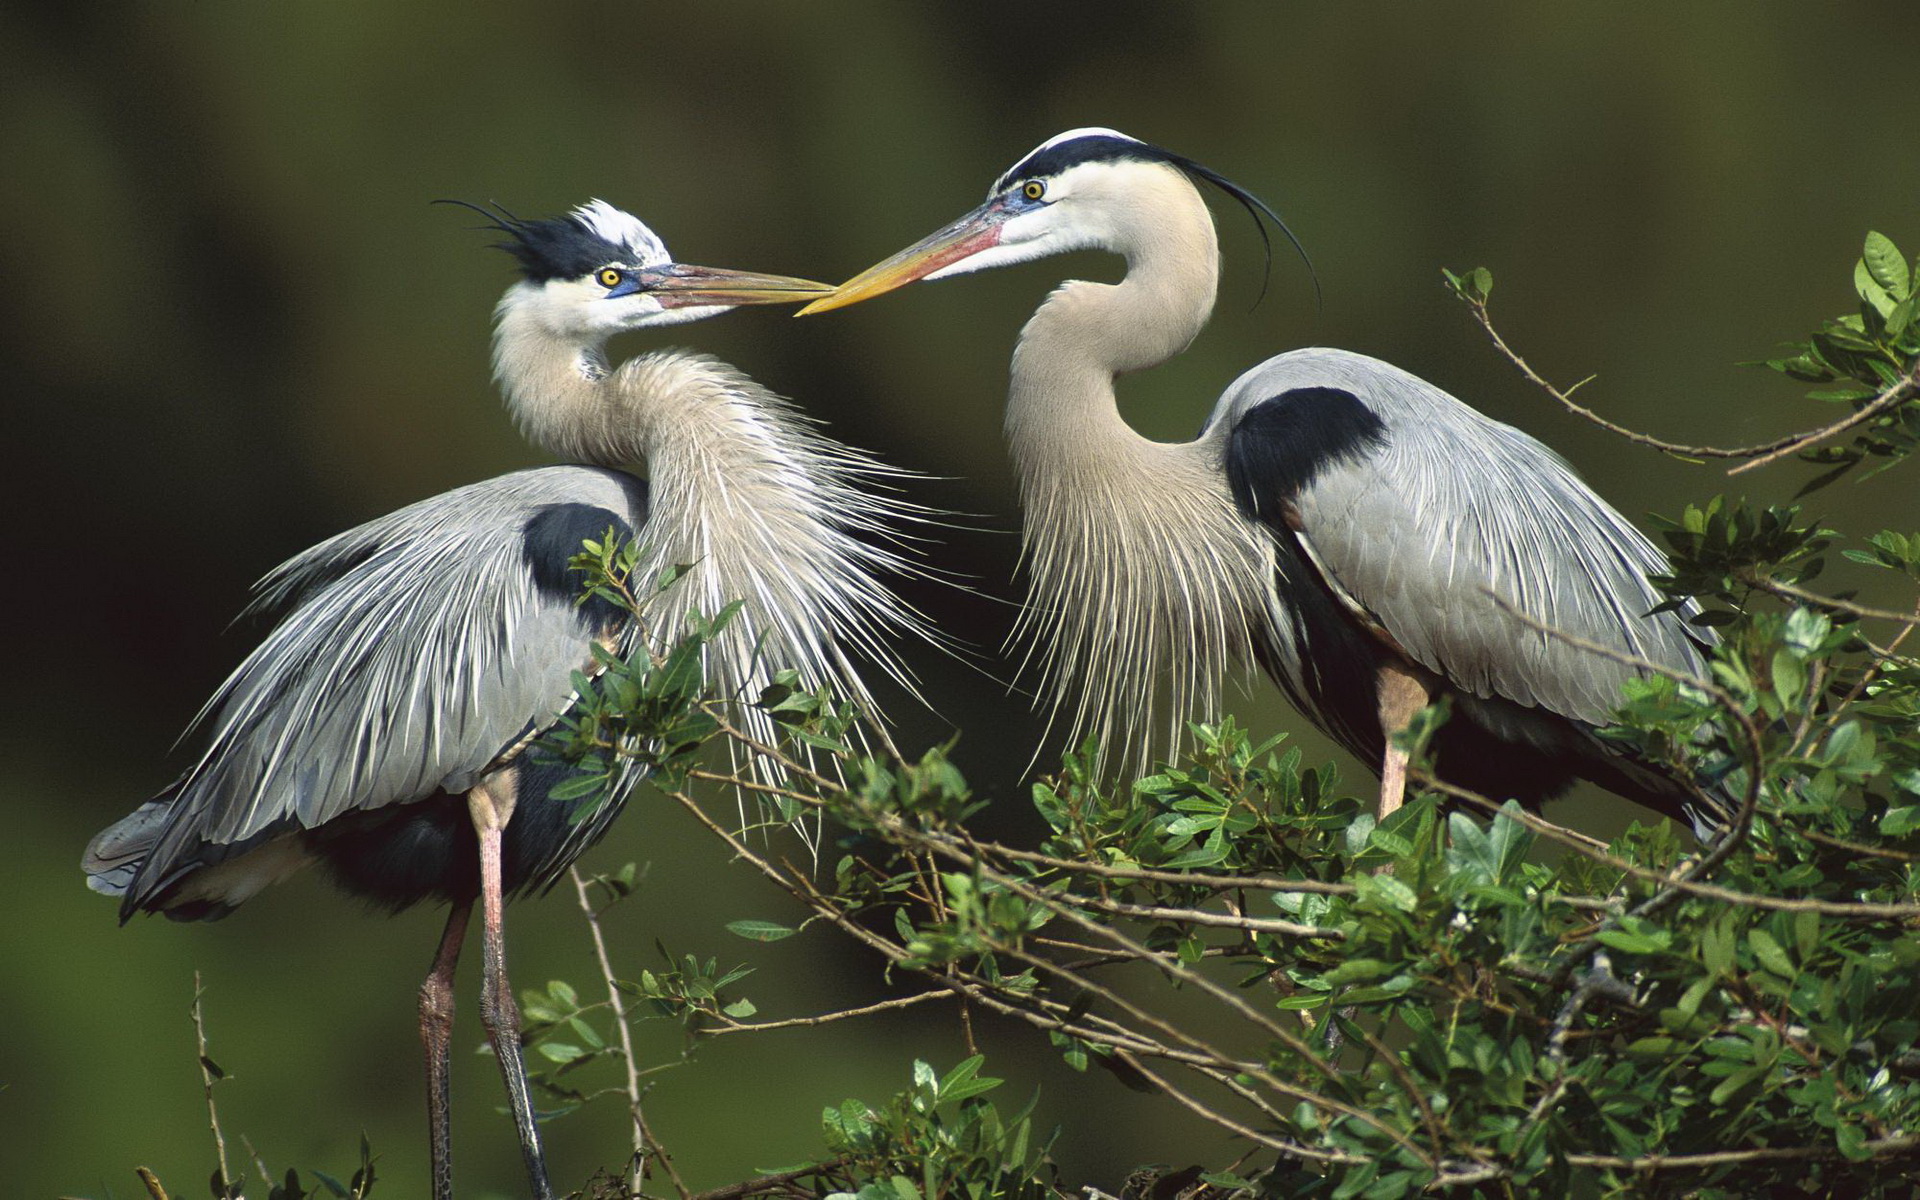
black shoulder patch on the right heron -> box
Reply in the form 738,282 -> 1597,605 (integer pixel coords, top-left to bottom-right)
1227,388 -> 1386,526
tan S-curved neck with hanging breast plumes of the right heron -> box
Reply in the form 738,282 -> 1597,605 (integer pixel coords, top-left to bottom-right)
1006,169 -> 1273,764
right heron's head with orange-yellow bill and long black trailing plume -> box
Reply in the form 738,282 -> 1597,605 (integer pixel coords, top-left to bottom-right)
801,129 -> 1298,317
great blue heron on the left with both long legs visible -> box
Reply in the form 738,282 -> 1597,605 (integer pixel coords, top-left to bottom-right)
83,200 -> 920,1200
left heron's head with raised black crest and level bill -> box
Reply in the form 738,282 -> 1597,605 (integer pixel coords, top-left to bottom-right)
455,200 -> 831,342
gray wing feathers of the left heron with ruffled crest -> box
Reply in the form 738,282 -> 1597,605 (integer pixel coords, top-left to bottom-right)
156,467 -> 643,860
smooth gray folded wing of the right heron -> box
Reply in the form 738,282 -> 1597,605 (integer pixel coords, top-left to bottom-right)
1213,349 -> 1699,724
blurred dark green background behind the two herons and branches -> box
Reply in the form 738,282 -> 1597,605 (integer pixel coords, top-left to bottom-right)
0,0 -> 1920,1196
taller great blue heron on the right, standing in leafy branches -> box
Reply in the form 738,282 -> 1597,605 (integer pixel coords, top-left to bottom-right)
801,129 -> 1724,831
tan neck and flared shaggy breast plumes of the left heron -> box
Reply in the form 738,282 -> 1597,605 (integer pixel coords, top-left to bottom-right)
493,305 -> 925,735
